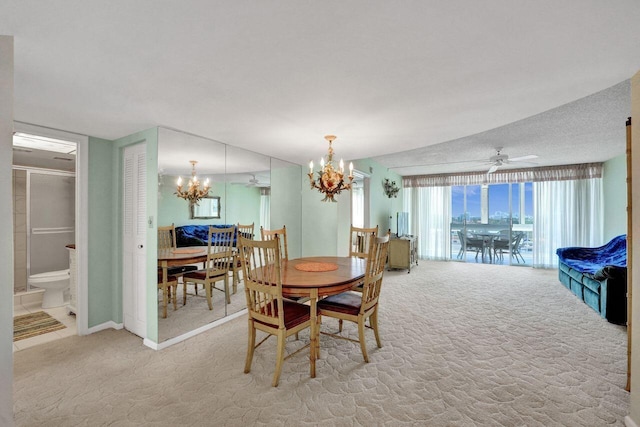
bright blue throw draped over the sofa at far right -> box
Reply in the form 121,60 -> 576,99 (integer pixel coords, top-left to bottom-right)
556,234 -> 627,275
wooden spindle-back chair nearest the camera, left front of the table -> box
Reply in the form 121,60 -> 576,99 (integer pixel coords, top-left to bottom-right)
238,235 -> 315,387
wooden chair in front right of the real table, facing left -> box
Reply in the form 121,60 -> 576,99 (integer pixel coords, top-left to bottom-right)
317,233 -> 389,363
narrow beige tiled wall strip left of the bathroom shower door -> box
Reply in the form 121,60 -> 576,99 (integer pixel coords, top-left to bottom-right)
13,169 -> 27,293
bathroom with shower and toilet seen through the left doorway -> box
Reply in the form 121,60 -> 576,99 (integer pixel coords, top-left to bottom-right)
12,132 -> 77,352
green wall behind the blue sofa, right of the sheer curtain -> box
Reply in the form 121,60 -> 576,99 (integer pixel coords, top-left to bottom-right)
602,155 -> 627,242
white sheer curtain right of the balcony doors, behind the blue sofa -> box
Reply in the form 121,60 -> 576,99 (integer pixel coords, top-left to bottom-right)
533,178 -> 604,268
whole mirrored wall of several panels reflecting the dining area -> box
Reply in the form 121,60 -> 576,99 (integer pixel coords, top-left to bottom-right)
157,128 -> 302,342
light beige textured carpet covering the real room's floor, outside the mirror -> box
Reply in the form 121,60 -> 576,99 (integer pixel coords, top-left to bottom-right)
14,261 -> 629,427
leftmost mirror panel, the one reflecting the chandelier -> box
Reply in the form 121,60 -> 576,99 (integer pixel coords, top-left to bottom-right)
157,128 -> 226,342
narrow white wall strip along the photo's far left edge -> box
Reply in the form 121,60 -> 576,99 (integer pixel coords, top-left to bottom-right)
0,36 -> 13,426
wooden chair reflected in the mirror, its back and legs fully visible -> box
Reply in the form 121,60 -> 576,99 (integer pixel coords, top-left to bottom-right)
183,226 -> 235,310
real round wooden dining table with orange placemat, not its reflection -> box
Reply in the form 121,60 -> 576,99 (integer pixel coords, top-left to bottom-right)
280,256 -> 366,378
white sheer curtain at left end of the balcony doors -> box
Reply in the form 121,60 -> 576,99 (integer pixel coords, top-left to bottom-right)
403,187 -> 451,260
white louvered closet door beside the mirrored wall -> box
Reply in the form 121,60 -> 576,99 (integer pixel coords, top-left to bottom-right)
122,143 -> 147,338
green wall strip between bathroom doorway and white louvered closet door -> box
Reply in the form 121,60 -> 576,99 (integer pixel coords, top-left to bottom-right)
87,137 -> 116,328
